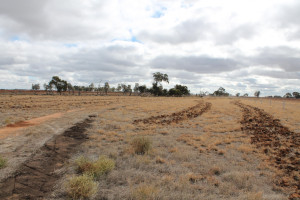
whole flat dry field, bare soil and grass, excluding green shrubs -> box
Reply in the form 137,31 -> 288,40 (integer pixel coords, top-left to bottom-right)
0,95 -> 300,200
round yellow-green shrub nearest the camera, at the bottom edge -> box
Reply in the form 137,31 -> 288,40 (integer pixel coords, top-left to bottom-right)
67,174 -> 98,200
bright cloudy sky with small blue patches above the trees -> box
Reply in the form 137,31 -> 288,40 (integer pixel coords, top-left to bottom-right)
0,0 -> 300,96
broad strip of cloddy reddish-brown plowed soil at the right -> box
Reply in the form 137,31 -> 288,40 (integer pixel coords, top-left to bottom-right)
235,102 -> 300,199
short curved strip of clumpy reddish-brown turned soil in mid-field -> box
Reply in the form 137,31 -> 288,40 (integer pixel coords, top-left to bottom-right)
133,102 -> 211,125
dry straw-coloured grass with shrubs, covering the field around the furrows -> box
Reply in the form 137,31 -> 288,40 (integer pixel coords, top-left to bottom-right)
0,96 -> 300,200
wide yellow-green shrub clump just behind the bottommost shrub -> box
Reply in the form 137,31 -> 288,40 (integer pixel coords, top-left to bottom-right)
76,156 -> 115,179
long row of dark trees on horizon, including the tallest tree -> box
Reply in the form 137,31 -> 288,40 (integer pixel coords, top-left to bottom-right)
32,72 -> 190,96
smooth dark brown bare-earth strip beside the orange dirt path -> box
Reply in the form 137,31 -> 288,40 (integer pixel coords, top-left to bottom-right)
0,115 -> 95,200
